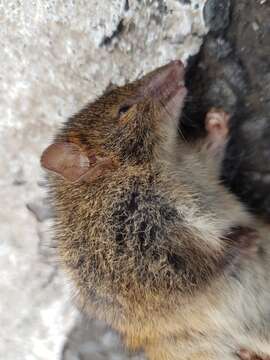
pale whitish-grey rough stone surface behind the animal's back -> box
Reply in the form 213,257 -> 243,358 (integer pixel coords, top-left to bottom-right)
0,0 -> 206,360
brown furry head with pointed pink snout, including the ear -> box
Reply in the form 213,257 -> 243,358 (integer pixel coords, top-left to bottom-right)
41,61 -> 186,182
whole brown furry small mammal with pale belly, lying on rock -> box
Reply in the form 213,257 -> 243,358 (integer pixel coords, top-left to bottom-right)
41,61 -> 270,360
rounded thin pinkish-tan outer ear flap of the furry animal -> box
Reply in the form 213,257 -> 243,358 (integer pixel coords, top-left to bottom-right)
41,142 -> 90,182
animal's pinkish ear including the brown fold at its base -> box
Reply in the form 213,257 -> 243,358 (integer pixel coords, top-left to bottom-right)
41,142 -> 115,182
